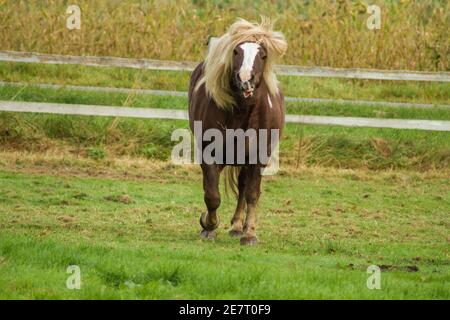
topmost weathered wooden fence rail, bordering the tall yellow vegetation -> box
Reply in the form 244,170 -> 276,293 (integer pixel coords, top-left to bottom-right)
0,51 -> 450,82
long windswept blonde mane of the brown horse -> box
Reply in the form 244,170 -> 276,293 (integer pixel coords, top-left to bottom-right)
195,17 -> 287,108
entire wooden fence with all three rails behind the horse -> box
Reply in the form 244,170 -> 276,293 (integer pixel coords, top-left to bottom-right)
0,51 -> 450,131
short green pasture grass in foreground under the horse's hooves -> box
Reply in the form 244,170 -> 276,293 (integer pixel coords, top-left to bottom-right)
0,166 -> 450,299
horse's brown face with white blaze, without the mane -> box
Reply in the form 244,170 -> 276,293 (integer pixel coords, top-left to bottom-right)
232,42 -> 267,98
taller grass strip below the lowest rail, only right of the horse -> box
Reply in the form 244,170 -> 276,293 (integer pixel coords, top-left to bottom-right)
280,124 -> 450,171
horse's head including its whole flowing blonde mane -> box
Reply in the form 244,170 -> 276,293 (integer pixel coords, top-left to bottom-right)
199,18 -> 287,109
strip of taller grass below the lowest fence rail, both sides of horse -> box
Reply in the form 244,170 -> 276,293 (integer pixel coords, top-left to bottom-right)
0,112 -> 450,171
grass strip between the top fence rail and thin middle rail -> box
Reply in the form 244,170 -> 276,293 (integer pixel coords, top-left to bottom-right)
0,62 -> 450,104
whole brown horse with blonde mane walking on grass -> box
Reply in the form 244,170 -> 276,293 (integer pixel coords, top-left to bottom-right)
188,17 -> 287,245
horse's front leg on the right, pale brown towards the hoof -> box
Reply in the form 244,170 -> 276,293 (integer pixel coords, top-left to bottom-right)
241,165 -> 261,245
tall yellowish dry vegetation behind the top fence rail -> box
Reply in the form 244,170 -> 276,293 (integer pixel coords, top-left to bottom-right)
0,0 -> 450,71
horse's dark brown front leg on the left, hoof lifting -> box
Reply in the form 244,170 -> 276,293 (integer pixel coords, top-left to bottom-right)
200,164 -> 222,239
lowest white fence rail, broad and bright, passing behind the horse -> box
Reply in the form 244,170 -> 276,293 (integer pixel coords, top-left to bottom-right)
0,101 -> 450,131
